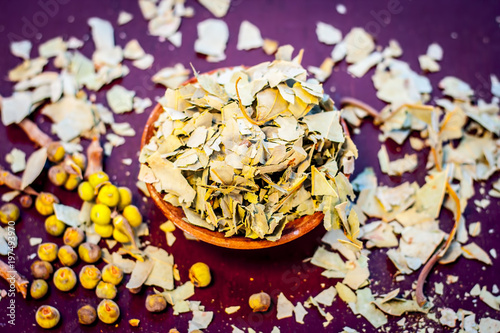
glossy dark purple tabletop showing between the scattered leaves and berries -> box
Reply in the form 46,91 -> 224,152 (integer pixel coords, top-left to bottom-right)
0,0 -> 500,332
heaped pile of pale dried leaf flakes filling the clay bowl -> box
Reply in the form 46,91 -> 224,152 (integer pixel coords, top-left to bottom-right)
139,46 -> 360,244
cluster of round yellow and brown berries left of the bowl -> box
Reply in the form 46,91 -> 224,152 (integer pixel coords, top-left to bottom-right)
28,158 -> 142,328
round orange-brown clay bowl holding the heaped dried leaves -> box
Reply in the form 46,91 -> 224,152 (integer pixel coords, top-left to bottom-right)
141,72 -> 348,250
